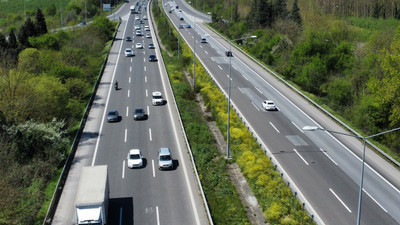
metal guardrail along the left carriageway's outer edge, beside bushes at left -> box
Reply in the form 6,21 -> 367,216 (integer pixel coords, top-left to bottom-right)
43,20 -> 121,225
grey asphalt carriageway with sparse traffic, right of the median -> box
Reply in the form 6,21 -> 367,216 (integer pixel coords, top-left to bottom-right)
163,0 -> 400,224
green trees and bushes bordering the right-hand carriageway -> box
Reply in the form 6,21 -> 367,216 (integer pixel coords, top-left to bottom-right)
192,0 -> 400,161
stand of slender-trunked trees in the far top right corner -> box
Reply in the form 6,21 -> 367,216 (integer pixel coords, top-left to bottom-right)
316,0 -> 400,19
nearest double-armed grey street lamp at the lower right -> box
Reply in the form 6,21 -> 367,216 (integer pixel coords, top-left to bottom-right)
303,126 -> 400,225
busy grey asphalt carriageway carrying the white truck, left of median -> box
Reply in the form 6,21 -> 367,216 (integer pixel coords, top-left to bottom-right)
52,1 -> 210,225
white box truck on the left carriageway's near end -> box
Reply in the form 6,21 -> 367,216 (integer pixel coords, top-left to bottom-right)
74,165 -> 110,225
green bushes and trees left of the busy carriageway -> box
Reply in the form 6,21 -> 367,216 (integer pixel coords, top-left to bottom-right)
0,7 -> 115,224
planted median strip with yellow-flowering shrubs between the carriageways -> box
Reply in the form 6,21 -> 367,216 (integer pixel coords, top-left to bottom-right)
153,0 -> 314,225
